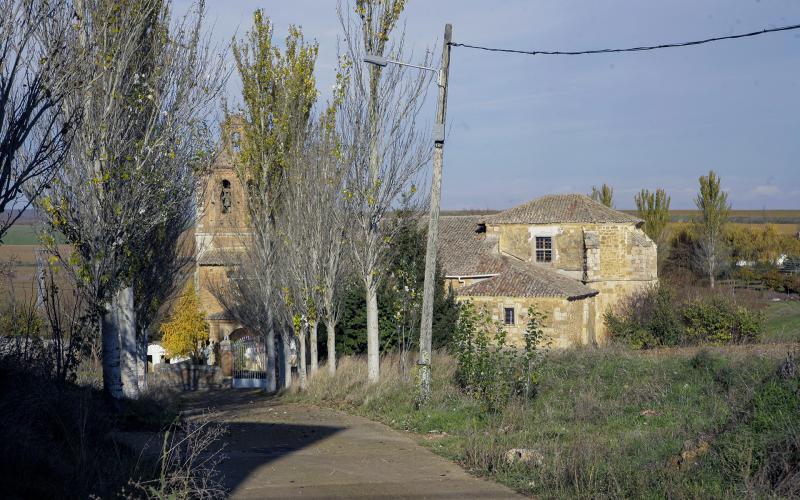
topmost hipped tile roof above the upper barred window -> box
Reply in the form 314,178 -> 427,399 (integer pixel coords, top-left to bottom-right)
481,194 -> 642,224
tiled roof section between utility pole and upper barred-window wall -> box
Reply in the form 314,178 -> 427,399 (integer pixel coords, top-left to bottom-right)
438,215 -> 503,276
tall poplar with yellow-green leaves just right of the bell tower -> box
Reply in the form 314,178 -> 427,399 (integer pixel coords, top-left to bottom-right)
222,10 -> 318,391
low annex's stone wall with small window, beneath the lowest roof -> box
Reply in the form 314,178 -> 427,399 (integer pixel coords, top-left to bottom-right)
459,297 -> 596,348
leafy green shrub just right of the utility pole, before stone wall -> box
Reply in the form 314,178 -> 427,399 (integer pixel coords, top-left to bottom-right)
453,303 -> 548,413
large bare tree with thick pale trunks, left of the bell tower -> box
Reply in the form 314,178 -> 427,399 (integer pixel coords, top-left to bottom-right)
31,0 -> 227,399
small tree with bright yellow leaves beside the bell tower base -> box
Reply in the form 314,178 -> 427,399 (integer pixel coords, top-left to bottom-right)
161,281 -> 208,360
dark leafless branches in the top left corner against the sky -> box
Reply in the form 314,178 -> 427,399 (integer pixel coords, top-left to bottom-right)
0,0 -> 79,240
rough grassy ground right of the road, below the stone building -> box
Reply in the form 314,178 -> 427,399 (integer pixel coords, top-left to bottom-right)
283,345 -> 800,498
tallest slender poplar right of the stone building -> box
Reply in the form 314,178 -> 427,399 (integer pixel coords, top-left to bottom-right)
694,170 -> 731,288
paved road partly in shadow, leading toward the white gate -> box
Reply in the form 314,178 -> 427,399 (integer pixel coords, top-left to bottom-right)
182,391 -> 517,498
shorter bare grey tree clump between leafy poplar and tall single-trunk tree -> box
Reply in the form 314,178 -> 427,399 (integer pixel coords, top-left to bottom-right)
277,112 -> 346,378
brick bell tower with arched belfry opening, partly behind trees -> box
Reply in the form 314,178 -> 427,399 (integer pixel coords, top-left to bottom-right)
195,122 -> 250,344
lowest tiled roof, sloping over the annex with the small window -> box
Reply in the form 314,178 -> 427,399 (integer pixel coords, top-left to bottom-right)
458,257 -> 598,299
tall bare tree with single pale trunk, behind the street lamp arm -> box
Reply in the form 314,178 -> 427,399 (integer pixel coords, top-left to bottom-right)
338,0 -> 431,382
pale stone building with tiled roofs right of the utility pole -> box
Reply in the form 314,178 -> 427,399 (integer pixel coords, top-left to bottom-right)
439,194 -> 658,347
